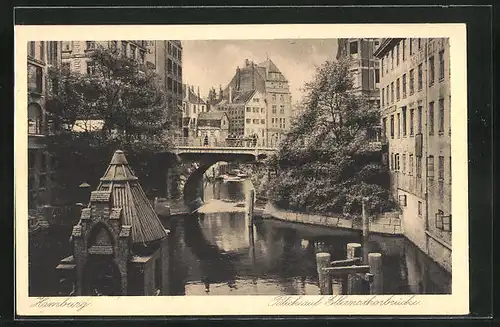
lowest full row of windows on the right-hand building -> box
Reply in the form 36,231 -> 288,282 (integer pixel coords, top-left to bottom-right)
389,153 -> 451,184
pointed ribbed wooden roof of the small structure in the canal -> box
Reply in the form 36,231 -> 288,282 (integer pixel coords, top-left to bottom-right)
97,150 -> 167,243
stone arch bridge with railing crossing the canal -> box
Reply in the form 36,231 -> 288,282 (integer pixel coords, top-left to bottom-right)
158,146 -> 276,211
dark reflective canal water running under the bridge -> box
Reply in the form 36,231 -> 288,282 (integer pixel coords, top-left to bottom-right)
29,181 -> 451,296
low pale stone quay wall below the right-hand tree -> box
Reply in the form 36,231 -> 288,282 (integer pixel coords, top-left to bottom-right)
257,203 -> 403,236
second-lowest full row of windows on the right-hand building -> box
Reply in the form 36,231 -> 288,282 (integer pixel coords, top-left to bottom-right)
382,99 -> 451,139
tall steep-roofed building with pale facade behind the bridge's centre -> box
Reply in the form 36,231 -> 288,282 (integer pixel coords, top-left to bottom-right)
218,59 -> 293,146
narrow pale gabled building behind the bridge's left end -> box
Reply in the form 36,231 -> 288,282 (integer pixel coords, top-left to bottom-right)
182,84 -> 208,137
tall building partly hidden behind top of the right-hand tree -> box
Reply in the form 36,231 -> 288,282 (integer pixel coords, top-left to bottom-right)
337,38 -> 380,106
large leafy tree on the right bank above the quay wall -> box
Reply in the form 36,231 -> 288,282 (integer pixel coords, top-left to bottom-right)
269,59 -> 395,216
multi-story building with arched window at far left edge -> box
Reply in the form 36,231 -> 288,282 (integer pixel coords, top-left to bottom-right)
27,41 -> 61,209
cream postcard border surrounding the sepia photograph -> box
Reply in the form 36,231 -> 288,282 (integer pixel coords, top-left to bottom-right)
14,24 -> 469,316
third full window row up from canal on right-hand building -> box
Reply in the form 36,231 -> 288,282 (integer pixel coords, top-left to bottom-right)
381,51 -> 445,107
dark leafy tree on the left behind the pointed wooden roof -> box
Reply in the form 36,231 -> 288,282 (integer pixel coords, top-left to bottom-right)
47,48 -> 172,202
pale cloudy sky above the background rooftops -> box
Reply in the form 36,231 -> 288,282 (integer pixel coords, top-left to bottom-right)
182,39 -> 337,102
